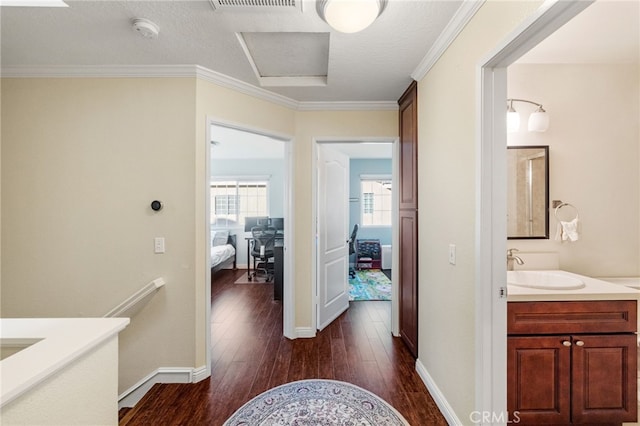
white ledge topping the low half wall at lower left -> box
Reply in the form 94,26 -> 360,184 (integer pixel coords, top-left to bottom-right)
0,318 -> 129,406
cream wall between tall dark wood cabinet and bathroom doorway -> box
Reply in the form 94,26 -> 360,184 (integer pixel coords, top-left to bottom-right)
418,1 -> 540,423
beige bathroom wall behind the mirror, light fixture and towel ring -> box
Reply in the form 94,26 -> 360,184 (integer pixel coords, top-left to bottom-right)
508,64 -> 640,276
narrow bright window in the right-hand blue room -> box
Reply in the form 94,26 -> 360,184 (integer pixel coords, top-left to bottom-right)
360,176 -> 392,226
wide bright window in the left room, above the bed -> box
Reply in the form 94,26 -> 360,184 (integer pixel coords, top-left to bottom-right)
211,179 -> 269,227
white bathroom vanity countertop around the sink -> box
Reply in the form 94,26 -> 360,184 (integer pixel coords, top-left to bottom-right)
507,271 -> 640,302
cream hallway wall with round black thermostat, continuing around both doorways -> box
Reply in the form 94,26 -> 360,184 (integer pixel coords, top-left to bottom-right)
1,78 -> 397,392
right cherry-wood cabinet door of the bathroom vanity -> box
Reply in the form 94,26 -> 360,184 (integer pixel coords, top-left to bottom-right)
572,334 -> 638,423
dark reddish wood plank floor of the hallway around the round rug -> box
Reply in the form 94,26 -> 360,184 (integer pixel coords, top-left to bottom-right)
120,270 -> 447,426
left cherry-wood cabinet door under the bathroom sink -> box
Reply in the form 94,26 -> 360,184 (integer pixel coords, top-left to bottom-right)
507,336 -> 571,424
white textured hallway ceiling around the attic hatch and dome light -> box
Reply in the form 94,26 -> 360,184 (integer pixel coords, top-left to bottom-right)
1,0 -> 463,102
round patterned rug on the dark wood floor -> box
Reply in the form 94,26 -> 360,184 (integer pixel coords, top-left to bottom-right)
224,380 -> 409,426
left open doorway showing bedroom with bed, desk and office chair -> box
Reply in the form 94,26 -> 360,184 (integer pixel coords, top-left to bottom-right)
206,120 -> 293,353
